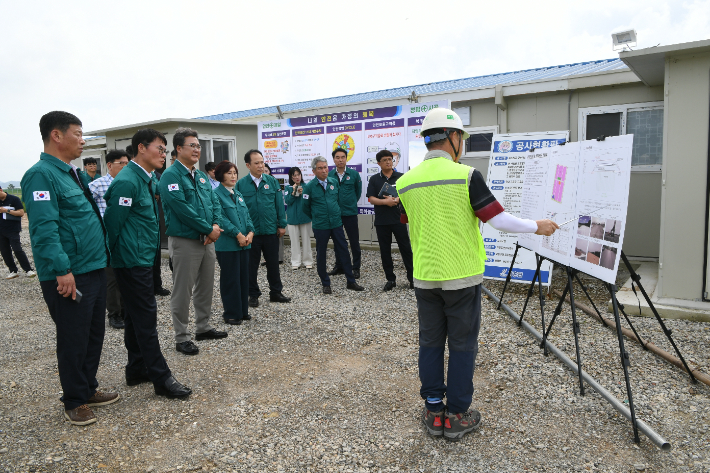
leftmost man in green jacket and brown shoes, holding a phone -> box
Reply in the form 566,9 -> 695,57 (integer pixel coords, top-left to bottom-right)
21,112 -> 119,425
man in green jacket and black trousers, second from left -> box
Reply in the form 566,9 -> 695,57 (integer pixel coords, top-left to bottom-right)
104,128 -> 192,398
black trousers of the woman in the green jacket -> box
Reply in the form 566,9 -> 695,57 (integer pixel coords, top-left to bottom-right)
216,250 -> 249,320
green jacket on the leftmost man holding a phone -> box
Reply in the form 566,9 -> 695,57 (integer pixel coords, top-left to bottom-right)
21,153 -> 108,281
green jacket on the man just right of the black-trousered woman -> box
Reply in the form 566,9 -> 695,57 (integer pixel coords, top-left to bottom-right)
235,174 -> 286,235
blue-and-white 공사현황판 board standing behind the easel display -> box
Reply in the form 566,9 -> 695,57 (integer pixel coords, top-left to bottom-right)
481,131 -> 569,285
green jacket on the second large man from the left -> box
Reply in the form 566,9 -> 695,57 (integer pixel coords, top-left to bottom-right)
104,162 -> 160,268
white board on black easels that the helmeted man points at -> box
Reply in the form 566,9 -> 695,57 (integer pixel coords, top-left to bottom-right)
518,135 -> 633,284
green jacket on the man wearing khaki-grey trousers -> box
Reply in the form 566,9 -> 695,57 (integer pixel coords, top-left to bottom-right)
158,161 -> 222,240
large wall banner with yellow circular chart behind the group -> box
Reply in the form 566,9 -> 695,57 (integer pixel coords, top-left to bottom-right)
258,100 -> 449,214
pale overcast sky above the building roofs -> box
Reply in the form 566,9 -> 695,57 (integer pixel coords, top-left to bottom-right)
0,0 -> 710,181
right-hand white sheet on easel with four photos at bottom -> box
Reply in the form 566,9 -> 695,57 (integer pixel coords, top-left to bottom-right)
569,135 -> 633,284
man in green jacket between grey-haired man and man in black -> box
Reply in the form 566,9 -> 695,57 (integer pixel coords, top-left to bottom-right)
328,148 -> 362,279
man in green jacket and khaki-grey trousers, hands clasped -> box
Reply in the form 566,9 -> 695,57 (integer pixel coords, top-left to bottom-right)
158,128 -> 227,355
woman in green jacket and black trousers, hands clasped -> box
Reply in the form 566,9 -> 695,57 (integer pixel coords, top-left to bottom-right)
214,161 -> 254,325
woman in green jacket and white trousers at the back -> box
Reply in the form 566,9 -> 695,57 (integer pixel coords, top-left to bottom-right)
284,166 -> 313,271
